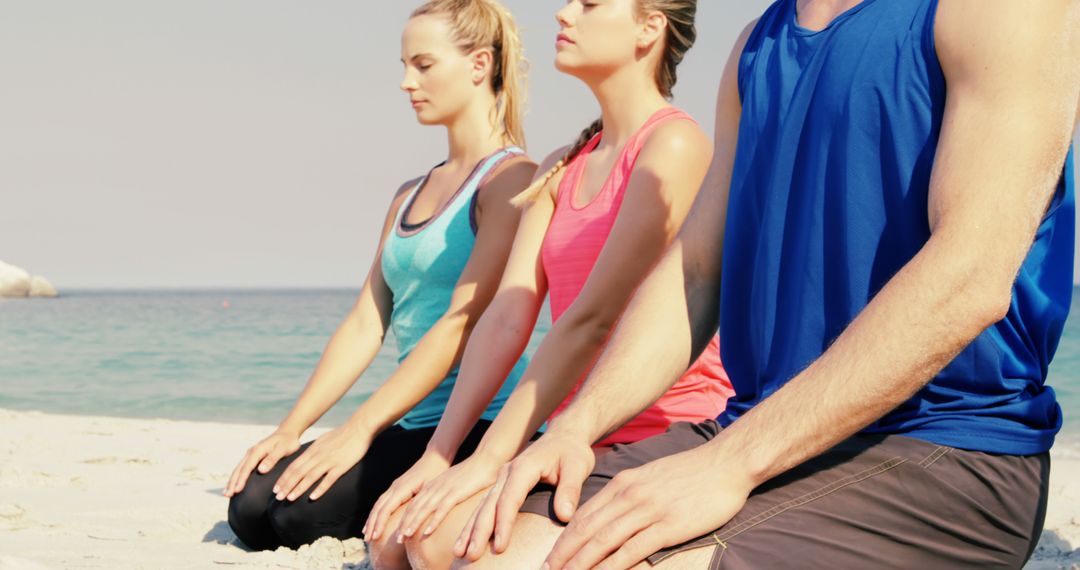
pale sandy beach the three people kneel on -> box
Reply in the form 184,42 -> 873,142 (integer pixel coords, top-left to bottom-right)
0,410 -> 1080,570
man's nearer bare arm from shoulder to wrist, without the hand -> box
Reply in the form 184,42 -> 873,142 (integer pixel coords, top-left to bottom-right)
706,0 -> 1080,485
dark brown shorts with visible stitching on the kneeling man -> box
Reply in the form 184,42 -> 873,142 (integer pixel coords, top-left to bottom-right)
522,421 -> 1050,569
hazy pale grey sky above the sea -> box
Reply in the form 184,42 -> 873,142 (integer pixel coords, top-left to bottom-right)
0,0 -> 1075,288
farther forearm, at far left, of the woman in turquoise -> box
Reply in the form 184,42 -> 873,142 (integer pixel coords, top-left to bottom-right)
278,315 -> 382,437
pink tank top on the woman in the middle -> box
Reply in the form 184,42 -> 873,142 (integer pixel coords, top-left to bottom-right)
541,107 -> 734,447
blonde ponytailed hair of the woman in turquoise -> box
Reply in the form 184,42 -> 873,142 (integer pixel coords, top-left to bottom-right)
411,0 -> 528,148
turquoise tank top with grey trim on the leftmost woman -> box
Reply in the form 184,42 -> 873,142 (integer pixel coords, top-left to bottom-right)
381,147 -> 528,430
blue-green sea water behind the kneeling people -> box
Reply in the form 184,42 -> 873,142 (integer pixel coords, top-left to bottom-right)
0,289 -> 1080,439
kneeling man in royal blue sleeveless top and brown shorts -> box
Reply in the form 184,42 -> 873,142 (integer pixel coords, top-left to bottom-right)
457,0 -> 1080,569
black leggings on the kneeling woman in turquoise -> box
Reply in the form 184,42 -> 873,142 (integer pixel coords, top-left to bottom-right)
229,420 -> 491,551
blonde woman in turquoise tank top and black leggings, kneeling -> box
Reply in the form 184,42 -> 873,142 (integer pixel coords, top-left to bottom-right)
225,0 -> 536,557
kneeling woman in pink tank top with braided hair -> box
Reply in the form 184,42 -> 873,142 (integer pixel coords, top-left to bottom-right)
364,0 -> 731,569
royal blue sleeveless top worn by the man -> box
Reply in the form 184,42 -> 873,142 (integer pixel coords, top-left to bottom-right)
718,0 -> 1076,454
